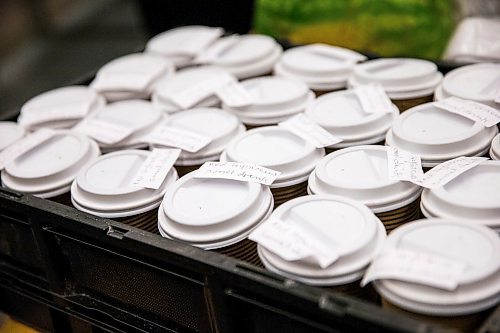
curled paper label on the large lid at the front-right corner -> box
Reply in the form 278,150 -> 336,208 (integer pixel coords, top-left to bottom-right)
361,250 -> 466,291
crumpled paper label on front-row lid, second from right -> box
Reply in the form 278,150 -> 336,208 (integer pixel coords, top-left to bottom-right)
248,219 -> 339,268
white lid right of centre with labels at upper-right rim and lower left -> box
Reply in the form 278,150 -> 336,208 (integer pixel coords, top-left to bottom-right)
306,90 -> 399,148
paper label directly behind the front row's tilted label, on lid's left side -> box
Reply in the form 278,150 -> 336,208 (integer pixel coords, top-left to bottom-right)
142,125 -> 212,153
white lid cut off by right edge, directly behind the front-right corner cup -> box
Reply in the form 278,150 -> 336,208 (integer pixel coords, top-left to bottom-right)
422,161 -> 500,227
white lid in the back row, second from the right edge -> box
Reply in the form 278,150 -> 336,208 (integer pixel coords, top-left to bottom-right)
349,58 -> 443,99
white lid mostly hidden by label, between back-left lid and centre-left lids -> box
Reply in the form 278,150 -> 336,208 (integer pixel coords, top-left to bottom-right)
153,66 -> 231,110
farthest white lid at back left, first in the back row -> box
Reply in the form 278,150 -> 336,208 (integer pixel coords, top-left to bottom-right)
146,25 -> 224,60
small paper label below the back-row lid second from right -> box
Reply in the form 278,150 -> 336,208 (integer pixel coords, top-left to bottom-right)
354,84 -> 394,113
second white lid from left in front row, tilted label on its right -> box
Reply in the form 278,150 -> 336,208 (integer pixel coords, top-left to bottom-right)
71,150 -> 177,218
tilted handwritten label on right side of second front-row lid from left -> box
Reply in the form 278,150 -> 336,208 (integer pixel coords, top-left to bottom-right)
130,148 -> 181,190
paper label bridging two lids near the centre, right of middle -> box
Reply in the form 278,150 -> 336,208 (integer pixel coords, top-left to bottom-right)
278,113 -> 342,148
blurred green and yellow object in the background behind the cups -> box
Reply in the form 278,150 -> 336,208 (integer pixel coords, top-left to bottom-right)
254,0 -> 455,59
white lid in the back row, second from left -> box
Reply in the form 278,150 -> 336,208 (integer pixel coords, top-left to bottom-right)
207,35 -> 277,67
